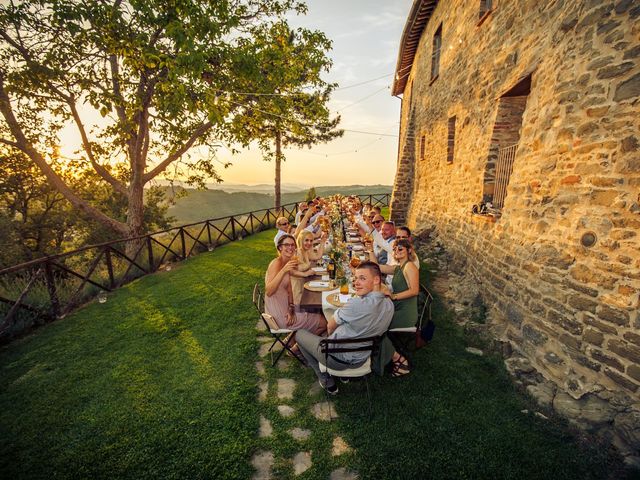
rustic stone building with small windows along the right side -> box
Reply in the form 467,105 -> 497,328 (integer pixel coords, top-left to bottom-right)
391,0 -> 640,461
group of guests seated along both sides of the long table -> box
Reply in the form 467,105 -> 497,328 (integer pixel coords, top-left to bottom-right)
265,197 -> 420,394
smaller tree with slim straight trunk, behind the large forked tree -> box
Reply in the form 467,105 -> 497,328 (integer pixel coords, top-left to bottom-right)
232,20 -> 344,207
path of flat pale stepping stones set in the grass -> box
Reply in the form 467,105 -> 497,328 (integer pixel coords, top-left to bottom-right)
251,322 -> 358,480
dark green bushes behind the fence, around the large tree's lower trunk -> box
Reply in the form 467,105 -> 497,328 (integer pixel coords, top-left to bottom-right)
0,145 -> 173,267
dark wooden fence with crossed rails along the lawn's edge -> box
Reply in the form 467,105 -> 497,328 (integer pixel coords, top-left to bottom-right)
0,193 -> 390,342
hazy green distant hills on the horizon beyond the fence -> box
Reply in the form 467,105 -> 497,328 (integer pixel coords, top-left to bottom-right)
168,185 -> 392,225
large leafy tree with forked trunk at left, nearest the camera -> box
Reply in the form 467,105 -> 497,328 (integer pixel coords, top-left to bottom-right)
0,0 -> 305,255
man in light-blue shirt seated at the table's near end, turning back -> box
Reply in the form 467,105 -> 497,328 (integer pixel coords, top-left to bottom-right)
296,262 -> 409,395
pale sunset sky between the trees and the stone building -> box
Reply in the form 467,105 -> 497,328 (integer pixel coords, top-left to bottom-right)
61,0 -> 412,186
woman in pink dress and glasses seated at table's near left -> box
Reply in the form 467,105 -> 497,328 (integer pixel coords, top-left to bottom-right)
264,234 -> 327,343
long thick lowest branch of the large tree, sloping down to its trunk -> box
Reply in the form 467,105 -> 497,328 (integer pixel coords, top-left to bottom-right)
0,72 -> 129,236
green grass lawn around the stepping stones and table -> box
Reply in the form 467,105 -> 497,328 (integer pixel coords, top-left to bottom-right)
0,231 -> 632,480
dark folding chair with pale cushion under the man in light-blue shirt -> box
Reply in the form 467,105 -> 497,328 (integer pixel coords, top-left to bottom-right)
318,336 -> 382,415
